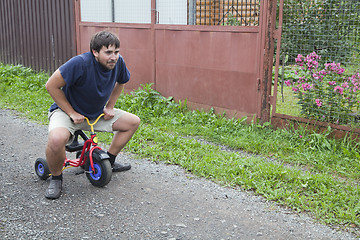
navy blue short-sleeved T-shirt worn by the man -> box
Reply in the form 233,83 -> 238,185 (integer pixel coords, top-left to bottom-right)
50,52 -> 130,119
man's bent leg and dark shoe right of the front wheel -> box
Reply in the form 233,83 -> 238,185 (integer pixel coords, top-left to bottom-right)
108,112 -> 140,172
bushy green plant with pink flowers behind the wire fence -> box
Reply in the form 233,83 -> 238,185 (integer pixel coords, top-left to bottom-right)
285,52 -> 360,124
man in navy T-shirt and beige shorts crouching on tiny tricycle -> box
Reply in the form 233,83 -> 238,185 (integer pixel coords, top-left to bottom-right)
45,31 -> 140,199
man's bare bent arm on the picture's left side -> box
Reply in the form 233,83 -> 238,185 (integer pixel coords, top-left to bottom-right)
45,69 -> 84,123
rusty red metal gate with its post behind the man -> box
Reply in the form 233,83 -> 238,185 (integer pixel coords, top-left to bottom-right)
75,0 -> 281,121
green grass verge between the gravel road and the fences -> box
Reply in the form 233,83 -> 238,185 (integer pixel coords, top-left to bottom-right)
0,62 -> 360,235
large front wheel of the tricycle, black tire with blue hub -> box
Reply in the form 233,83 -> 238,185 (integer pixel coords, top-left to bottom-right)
85,152 -> 112,187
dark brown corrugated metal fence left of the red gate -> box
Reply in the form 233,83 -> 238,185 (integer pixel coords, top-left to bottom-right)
0,0 -> 76,72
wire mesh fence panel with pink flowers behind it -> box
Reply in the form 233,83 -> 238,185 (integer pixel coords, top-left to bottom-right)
277,0 -> 360,127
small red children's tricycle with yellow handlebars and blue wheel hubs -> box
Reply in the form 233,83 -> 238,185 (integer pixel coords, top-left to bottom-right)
35,114 -> 112,187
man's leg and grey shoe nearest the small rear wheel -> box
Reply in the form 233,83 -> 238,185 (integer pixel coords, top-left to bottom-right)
45,127 -> 70,199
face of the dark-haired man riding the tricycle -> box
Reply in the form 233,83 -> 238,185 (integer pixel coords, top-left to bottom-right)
92,45 -> 119,70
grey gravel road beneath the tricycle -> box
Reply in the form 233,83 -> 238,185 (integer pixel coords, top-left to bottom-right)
0,109 -> 356,240
